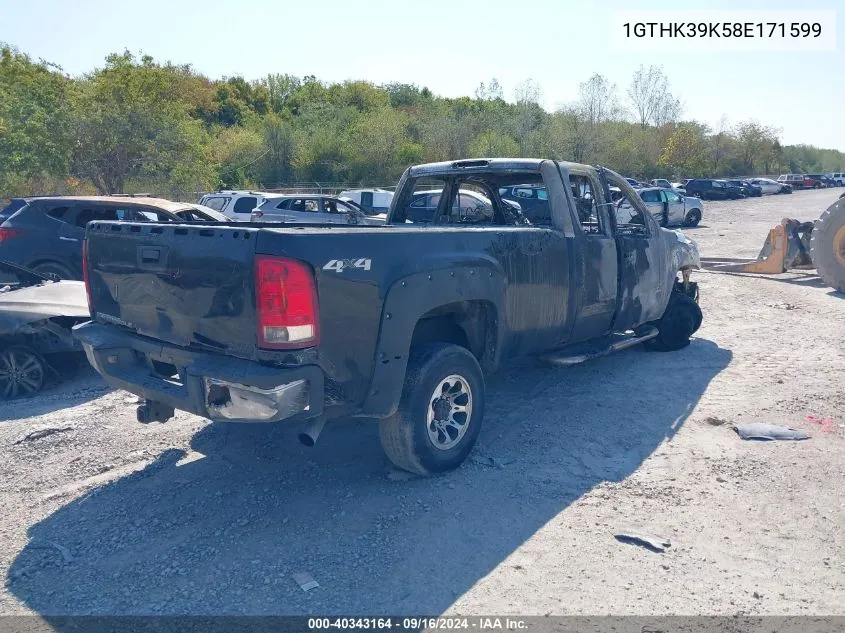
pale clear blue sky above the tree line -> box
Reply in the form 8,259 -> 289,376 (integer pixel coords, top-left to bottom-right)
0,0 -> 845,151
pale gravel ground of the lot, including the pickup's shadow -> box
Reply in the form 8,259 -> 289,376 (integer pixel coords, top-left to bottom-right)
0,190 -> 845,615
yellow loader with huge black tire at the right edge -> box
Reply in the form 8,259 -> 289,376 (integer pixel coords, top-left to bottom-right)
701,193 -> 845,292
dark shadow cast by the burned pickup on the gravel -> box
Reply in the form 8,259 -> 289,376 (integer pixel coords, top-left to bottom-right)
7,339 -> 732,616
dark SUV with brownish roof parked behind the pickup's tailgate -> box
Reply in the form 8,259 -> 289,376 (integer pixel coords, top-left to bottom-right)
0,196 -> 217,279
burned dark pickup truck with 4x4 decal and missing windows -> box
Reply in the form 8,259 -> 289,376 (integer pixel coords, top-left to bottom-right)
75,159 -> 701,475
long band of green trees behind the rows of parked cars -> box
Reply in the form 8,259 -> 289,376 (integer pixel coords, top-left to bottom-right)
0,44 -> 845,197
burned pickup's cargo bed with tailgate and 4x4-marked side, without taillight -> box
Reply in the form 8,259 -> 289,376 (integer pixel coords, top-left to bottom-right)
82,217 -> 569,403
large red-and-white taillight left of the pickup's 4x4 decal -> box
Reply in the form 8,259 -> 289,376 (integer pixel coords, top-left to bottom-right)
255,255 -> 319,349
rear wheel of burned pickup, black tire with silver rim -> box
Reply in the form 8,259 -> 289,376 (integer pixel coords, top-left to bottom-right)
379,343 -> 484,476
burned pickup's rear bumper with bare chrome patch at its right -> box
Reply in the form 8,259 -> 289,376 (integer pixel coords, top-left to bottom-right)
73,321 -> 324,422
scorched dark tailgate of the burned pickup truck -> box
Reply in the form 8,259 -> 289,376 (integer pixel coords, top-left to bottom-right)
86,222 -> 258,358
